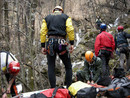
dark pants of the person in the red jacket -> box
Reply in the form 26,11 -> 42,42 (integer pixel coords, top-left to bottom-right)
99,50 -> 111,76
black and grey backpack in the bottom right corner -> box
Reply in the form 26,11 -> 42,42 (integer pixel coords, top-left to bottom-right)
100,77 -> 130,98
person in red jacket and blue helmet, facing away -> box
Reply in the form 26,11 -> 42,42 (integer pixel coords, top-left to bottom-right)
94,23 -> 115,76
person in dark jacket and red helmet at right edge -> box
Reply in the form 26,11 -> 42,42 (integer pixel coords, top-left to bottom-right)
114,26 -> 130,71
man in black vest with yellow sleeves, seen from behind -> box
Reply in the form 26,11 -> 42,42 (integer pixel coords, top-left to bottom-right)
40,6 -> 74,88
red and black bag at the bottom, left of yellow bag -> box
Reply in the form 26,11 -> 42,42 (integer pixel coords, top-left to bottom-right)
30,87 -> 71,98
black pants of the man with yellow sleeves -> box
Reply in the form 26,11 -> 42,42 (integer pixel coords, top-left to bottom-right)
47,39 -> 72,88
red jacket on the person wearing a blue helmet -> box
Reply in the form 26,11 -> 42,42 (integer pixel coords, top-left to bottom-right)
94,31 -> 115,56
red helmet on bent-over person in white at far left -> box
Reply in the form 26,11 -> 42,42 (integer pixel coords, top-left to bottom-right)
8,61 -> 20,75
